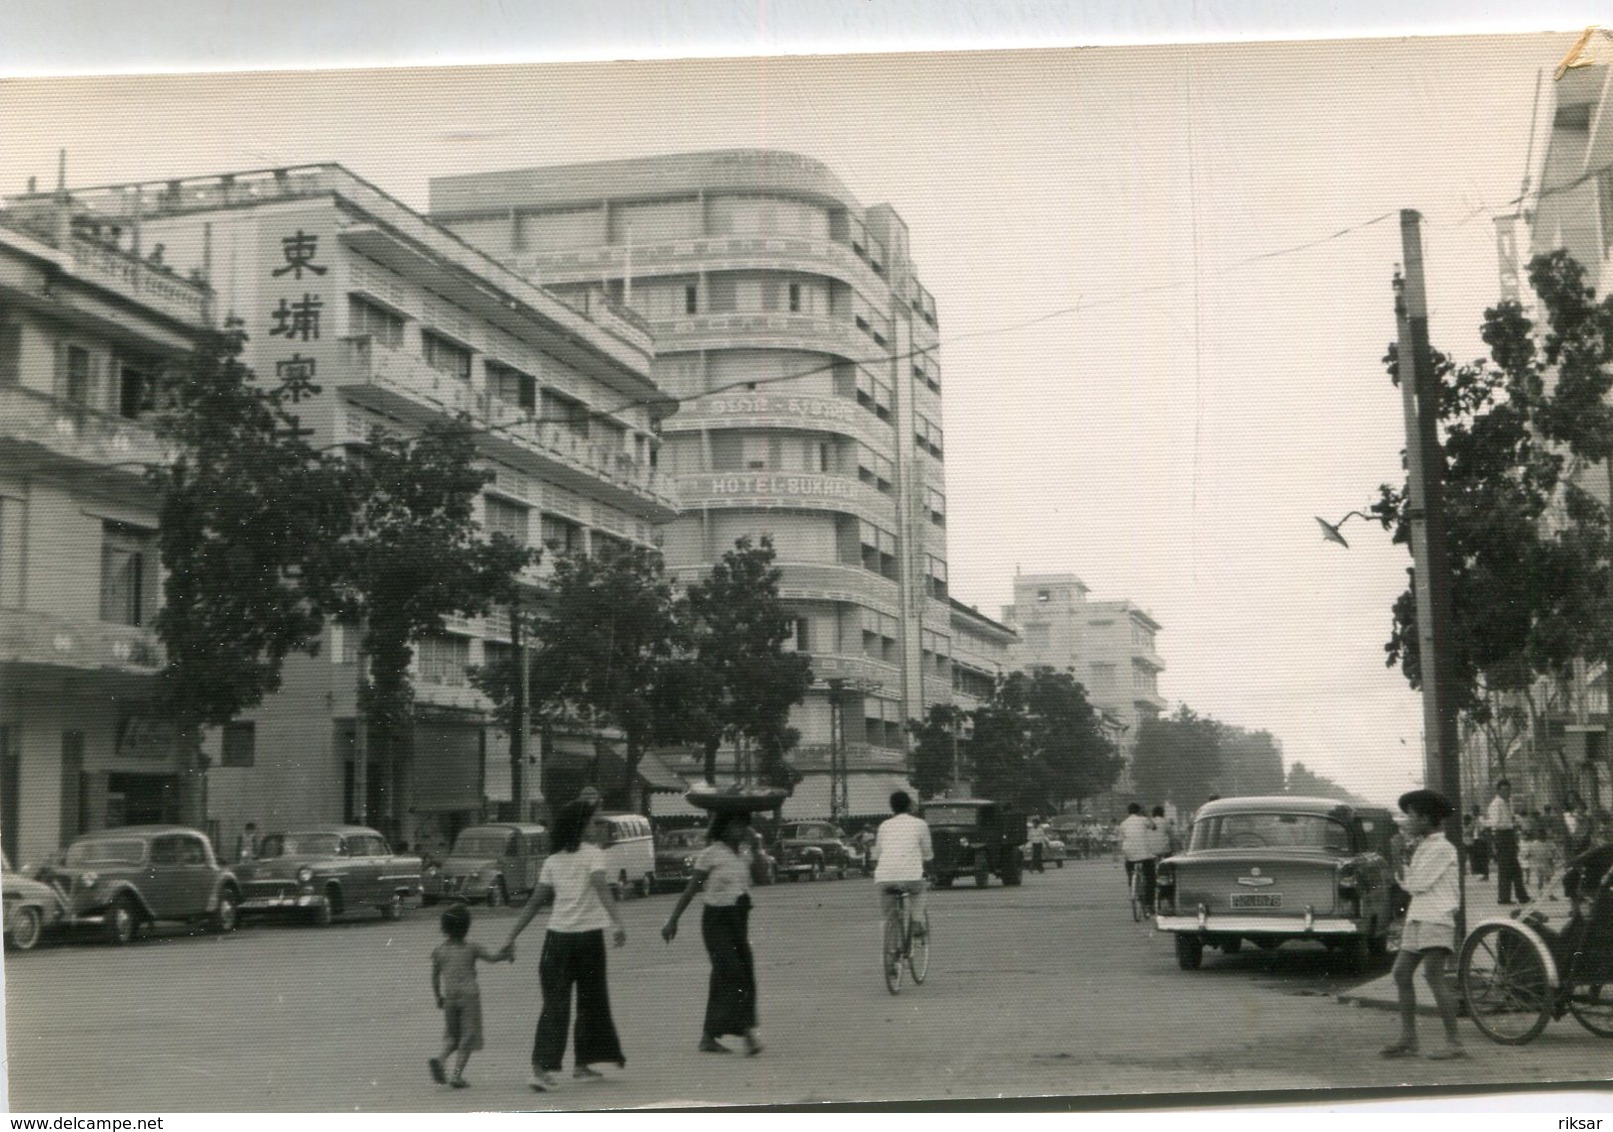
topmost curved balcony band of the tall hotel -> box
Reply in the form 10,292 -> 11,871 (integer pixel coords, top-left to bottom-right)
510,235 -> 890,297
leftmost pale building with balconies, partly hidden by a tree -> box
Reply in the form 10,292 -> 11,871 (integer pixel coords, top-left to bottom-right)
0,194 -> 211,863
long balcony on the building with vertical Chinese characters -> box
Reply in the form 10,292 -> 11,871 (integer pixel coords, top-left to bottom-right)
340,335 -> 677,522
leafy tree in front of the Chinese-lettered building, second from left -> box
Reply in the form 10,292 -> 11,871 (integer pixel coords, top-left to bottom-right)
337,419 -> 534,818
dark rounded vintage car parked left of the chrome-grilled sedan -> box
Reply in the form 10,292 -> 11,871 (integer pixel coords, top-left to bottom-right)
42,826 -> 240,945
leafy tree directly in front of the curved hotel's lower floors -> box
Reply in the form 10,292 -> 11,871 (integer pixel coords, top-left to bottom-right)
679,537 -> 813,789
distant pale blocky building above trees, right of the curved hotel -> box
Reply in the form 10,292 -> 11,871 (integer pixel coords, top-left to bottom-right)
1003,574 -> 1166,756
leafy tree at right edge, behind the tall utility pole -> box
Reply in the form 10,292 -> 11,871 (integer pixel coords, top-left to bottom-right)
1367,252 -> 1613,774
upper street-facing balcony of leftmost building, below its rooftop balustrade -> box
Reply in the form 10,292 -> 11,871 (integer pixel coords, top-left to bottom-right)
0,385 -> 174,477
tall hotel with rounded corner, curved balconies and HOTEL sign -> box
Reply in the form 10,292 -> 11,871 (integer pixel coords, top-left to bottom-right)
431,150 -> 952,818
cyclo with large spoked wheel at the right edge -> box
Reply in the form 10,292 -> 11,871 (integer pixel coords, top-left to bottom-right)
1457,845 -> 1613,1045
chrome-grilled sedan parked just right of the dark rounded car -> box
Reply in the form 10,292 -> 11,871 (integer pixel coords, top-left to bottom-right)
239,826 -> 421,926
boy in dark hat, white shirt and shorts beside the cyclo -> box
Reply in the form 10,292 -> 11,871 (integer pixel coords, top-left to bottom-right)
1381,790 -> 1468,1061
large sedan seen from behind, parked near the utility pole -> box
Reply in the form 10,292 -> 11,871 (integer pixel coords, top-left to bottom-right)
1157,795 -> 1394,971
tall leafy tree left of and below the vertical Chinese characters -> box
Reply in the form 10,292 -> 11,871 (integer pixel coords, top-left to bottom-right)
147,321 -> 352,826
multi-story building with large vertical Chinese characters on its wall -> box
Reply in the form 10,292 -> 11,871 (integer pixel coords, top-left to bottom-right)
6,164 -> 676,845
